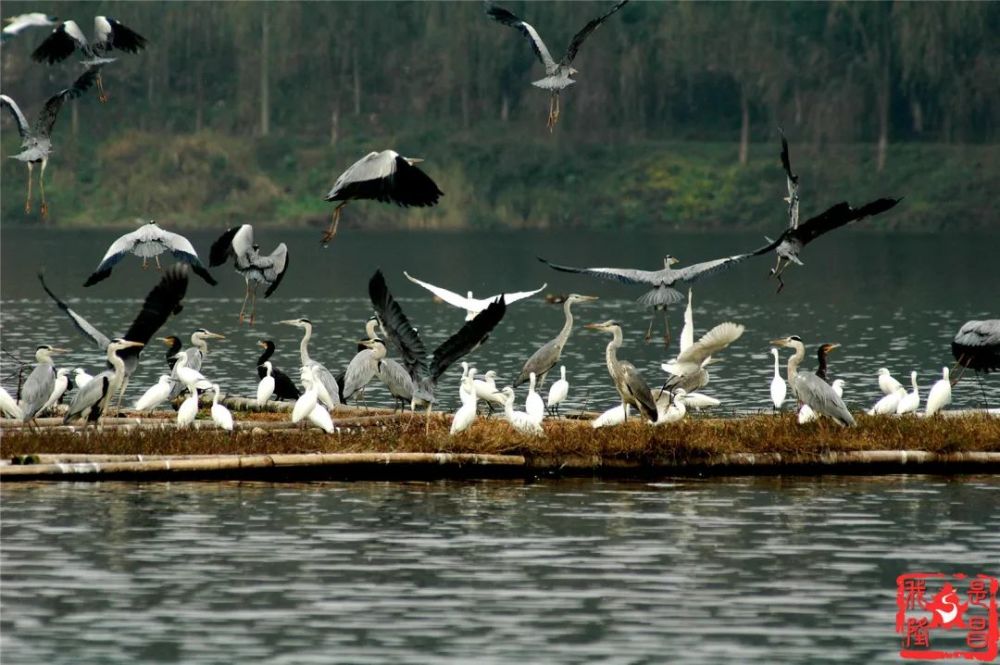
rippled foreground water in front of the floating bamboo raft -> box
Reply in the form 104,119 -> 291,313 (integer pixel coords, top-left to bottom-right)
0,476 -> 1000,664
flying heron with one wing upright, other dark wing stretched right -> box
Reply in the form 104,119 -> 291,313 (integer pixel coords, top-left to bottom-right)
752,132 -> 902,293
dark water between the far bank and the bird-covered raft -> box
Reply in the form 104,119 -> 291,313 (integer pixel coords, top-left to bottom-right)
0,228 -> 1000,410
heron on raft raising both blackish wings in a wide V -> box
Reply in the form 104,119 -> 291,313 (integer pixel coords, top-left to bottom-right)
368,270 -> 507,429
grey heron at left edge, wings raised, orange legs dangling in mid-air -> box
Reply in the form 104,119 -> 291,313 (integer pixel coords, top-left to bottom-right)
0,67 -> 98,217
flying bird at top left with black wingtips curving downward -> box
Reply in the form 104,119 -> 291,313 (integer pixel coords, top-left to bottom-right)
31,16 -> 146,102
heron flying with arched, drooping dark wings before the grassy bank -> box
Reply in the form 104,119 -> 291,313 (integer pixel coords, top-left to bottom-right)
321,150 -> 444,245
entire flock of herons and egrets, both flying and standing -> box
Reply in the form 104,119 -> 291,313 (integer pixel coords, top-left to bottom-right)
0,9 -> 1000,435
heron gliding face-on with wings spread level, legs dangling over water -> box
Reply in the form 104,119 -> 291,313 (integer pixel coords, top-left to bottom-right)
538,253 -> 754,348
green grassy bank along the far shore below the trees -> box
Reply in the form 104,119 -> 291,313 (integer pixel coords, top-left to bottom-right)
0,125 -> 1000,233
